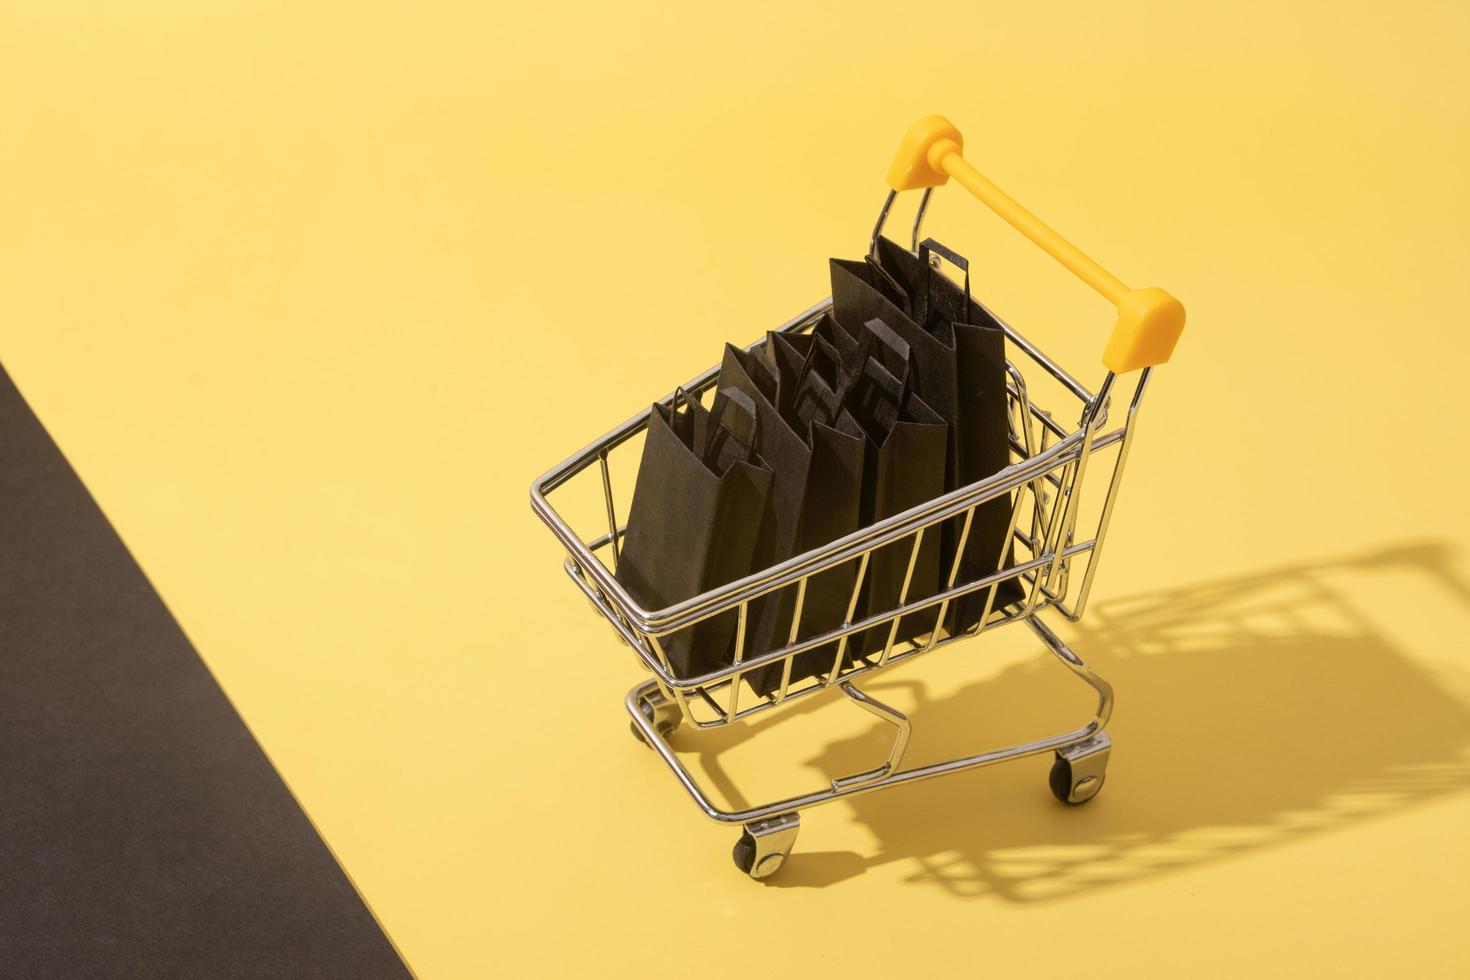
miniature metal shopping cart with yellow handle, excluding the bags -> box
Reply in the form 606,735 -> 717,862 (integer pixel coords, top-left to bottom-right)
531,116 -> 1185,879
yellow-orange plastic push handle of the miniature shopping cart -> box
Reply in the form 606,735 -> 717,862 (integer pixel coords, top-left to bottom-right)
888,116 -> 1185,375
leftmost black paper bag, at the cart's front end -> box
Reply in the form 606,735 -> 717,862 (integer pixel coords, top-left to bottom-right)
617,391 -> 775,677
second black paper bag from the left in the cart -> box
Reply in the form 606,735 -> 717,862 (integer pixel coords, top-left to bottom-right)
719,335 -> 866,695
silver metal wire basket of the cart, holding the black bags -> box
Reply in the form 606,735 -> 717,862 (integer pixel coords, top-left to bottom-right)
532,300 -> 1148,727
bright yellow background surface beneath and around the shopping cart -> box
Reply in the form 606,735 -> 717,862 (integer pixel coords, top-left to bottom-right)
0,1 -> 1470,977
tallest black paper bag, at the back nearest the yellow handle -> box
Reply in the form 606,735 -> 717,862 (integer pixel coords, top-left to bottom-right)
831,237 -> 1022,633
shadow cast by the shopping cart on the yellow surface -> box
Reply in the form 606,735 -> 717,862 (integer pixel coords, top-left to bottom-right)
682,544 -> 1470,902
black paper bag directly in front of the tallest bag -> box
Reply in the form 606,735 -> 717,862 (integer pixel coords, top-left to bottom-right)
842,357 -> 948,654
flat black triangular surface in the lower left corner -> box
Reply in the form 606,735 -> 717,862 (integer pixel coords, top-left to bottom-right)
0,370 -> 409,979
